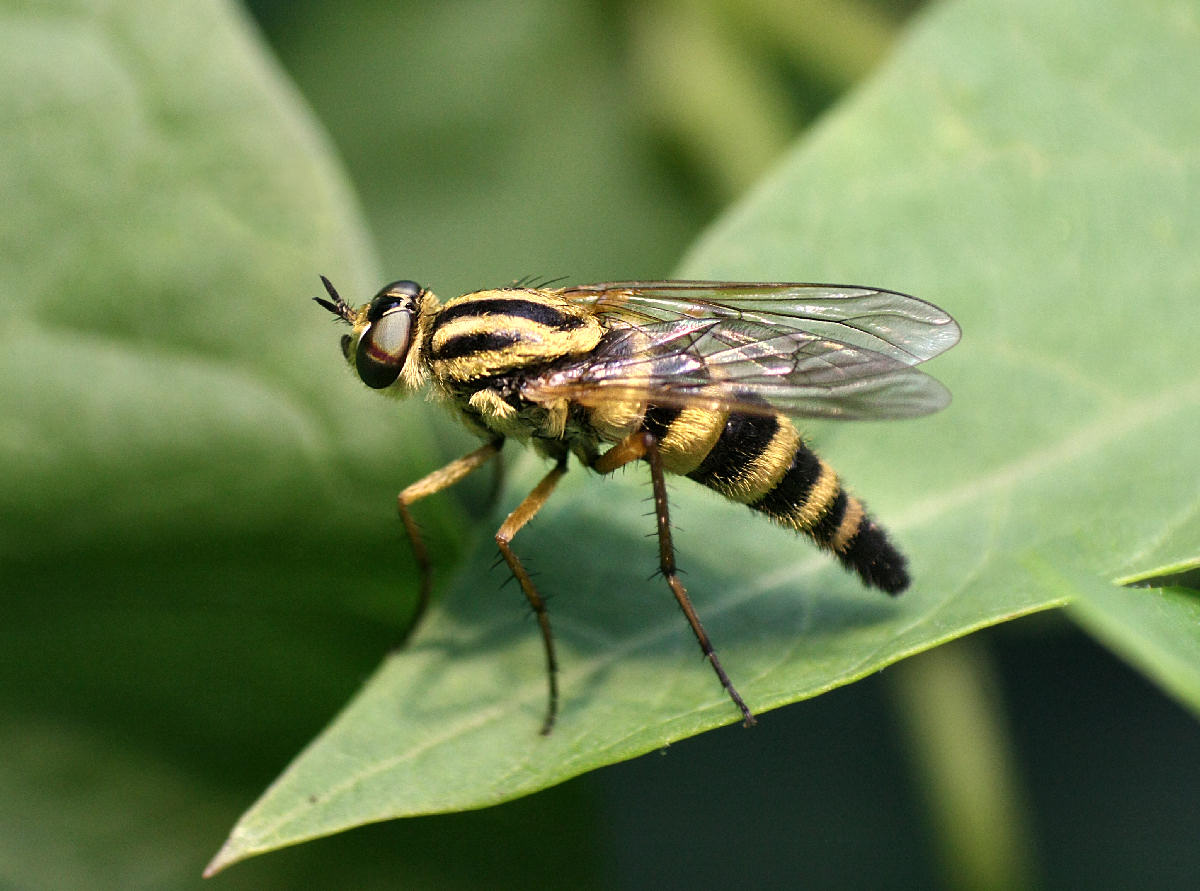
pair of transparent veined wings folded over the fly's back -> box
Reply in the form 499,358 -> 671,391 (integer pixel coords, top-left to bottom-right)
524,282 -> 959,419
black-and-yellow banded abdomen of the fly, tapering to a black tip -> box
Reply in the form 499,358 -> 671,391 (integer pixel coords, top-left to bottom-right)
643,406 -> 908,594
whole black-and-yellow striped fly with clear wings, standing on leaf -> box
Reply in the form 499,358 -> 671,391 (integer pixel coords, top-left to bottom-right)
316,276 -> 959,734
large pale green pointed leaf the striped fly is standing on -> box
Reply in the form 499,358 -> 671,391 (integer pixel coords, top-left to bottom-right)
212,0 -> 1200,868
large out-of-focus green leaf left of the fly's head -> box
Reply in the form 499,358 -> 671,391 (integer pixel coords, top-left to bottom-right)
0,2 -> 384,562
